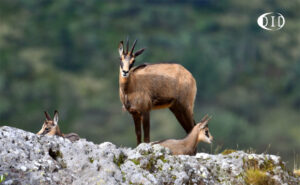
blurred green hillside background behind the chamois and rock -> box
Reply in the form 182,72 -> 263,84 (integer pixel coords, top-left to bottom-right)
0,0 -> 300,167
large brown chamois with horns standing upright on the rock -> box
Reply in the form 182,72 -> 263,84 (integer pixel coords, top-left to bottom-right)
119,40 -> 197,144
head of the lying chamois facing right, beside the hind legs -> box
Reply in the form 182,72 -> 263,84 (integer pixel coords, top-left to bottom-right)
195,115 -> 213,143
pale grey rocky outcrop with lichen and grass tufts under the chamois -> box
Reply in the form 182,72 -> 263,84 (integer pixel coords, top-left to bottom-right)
0,126 -> 300,185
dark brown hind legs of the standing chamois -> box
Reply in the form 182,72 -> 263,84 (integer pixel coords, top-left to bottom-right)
170,103 -> 195,133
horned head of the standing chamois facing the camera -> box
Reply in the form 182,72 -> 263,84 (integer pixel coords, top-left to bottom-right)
119,38 -> 145,78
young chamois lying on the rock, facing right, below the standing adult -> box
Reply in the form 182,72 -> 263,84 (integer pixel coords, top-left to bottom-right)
153,115 -> 213,155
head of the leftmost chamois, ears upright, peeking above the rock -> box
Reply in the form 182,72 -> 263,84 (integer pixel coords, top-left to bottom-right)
37,111 -> 61,136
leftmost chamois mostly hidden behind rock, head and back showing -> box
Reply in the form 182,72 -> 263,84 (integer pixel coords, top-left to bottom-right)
37,111 -> 80,141
